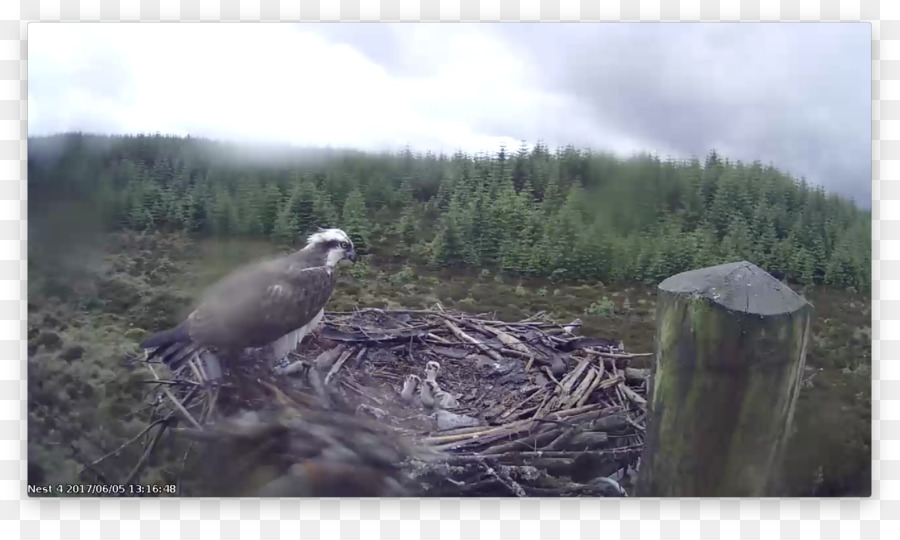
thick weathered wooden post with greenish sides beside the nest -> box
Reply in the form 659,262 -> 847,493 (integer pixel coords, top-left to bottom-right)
635,261 -> 812,497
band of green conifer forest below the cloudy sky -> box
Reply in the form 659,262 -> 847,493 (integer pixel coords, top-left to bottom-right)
28,134 -> 871,290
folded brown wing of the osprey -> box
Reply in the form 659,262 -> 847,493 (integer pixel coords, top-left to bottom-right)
188,261 -> 335,348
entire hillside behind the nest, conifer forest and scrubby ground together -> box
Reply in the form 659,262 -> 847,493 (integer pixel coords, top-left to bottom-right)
28,133 -> 872,496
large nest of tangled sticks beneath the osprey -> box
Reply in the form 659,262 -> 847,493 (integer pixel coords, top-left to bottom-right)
121,306 -> 648,496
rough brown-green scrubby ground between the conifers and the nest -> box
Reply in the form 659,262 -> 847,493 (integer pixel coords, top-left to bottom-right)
29,233 -> 871,495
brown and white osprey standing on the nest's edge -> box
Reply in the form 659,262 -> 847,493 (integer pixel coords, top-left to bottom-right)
141,229 -> 356,369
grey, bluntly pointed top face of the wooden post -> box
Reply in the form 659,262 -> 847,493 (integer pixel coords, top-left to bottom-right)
659,261 -> 807,316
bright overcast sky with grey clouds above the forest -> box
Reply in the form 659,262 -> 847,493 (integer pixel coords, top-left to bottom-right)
28,23 -> 872,206
